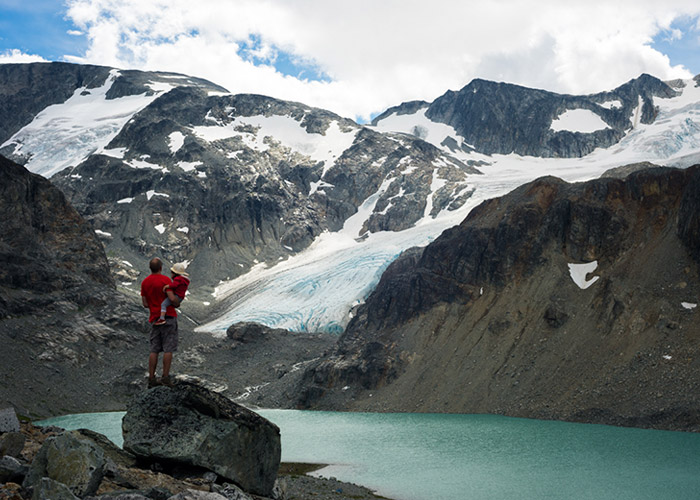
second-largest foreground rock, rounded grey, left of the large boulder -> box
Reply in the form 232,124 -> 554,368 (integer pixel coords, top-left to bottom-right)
23,431 -> 105,497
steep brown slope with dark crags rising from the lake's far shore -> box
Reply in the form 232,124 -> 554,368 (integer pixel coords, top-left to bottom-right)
301,167 -> 700,430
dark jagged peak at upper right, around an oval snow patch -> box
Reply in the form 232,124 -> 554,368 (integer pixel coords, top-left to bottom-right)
372,75 -> 675,158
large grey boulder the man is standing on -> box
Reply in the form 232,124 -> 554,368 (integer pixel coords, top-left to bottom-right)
122,383 -> 281,496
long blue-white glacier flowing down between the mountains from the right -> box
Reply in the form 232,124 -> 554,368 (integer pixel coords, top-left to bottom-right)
197,80 -> 700,336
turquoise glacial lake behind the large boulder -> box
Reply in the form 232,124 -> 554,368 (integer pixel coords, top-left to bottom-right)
40,410 -> 700,500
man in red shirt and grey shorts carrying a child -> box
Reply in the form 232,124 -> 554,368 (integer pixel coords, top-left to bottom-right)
141,257 -> 180,388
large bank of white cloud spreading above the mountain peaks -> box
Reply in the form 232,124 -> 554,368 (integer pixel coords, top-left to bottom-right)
61,0 -> 700,121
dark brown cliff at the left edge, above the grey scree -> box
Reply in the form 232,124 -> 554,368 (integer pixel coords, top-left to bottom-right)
0,157 -> 114,318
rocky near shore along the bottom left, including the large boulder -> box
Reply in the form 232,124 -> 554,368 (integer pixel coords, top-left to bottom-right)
0,383 -> 388,500
